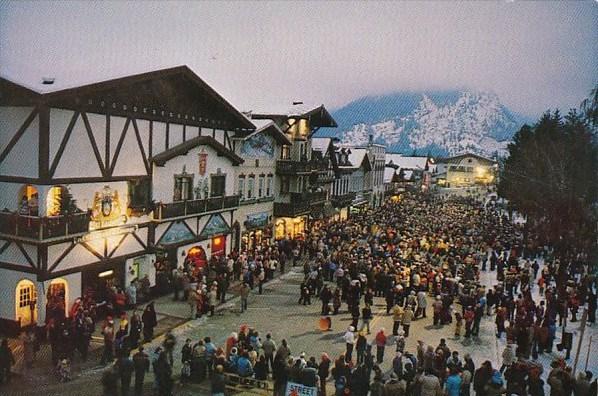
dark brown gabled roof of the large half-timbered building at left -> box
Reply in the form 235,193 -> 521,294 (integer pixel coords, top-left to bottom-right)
0,66 -> 255,130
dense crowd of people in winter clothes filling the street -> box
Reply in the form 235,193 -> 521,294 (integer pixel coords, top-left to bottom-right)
1,194 -> 596,396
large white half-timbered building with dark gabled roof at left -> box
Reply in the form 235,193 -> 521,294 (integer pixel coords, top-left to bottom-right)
0,66 -> 255,332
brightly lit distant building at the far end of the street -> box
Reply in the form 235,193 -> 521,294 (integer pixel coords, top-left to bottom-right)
432,153 -> 498,187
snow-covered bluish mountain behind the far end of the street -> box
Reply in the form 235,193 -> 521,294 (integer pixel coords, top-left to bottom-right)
318,91 -> 526,156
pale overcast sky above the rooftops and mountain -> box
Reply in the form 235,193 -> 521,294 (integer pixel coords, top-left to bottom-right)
0,0 -> 598,116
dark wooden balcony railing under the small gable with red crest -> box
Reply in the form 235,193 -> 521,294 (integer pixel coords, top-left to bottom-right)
154,195 -> 239,220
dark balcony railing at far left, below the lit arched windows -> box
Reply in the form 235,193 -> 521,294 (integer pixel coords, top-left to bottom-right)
0,212 -> 91,240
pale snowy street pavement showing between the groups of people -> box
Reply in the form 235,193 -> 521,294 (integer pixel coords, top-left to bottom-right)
0,258 -> 598,395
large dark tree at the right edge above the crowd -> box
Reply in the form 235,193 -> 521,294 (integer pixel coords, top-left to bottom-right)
499,110 -> 598,251
